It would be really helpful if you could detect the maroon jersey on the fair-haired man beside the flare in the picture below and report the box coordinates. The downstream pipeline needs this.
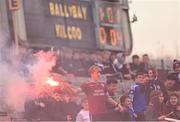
[81,82,107,115]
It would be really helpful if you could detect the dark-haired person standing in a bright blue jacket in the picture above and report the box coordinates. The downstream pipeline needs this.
[129,72,146,121]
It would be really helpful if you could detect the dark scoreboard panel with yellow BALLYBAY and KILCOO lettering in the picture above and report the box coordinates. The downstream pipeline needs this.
[23,0,96,48]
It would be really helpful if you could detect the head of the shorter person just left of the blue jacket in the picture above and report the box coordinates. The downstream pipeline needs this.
[120,95,132,108]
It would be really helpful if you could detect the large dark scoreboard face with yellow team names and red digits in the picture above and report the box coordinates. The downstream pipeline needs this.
[23,0,132,51]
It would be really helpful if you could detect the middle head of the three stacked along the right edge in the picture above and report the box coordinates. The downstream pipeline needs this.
[164,74,176,90]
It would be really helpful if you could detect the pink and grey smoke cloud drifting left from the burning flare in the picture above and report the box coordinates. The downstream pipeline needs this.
[0,32,56,112]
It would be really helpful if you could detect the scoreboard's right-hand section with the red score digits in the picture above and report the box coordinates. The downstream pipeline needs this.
[95,1,124,51]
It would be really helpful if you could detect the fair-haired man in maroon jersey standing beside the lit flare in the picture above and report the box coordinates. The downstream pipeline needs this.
[81,65,123,121]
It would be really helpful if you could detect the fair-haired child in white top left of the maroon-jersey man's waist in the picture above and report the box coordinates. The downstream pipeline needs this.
[76,98,90,122]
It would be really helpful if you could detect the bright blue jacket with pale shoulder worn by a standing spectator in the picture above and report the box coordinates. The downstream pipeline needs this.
[129,83,146,114]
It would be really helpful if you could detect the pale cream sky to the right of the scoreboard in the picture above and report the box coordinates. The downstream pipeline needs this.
[129,0,180,58]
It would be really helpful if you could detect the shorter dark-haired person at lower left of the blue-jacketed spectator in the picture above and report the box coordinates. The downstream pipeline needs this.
[120,95,137,121]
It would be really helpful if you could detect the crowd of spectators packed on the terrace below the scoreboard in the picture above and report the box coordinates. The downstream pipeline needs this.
[25,51,180,122]
